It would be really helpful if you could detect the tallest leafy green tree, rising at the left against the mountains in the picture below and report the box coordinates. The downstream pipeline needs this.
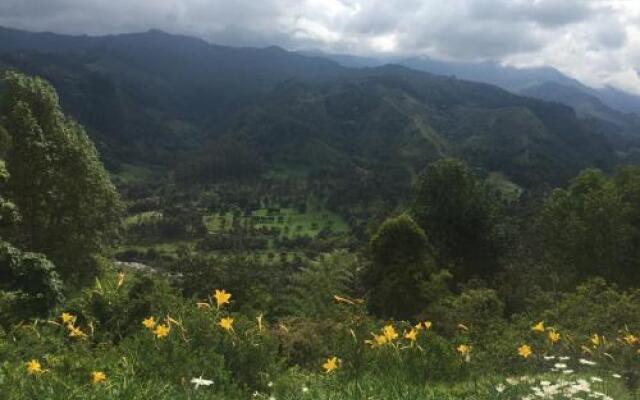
[0,72,121,276]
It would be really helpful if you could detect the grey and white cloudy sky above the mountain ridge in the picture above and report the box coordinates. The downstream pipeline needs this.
[0,0,640,93]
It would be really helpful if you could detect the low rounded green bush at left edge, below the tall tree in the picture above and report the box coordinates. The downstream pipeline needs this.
[0,242,64,324]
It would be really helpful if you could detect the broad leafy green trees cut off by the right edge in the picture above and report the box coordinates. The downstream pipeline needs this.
[539,168,640,284]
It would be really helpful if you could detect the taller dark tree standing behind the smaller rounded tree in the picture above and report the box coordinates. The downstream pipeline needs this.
[411,159,498,280]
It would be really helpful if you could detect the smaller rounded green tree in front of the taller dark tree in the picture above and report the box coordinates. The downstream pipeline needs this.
[364,214,435,318]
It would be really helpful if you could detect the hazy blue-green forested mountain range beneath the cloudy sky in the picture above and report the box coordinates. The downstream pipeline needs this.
[0,28,640,186]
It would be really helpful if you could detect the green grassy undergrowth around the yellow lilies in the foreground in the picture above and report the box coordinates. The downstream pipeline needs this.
[0,269,639,400]
